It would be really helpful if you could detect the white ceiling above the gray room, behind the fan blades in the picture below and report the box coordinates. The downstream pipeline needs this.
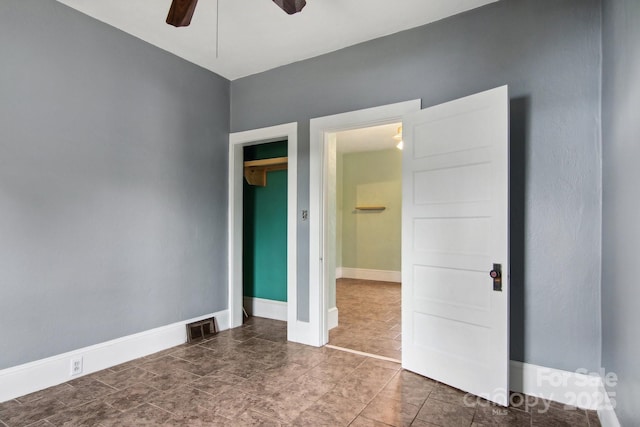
[58,0,497,80]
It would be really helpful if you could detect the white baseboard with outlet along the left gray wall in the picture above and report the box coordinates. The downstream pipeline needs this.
[0,310,229,402]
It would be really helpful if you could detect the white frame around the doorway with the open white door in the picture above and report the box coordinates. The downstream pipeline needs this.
[308,99,421,346]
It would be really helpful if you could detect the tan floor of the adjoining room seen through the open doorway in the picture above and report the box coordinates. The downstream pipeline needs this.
[329,279,402,361]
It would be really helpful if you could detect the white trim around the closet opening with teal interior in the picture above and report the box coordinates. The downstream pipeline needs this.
[228,122,299,341]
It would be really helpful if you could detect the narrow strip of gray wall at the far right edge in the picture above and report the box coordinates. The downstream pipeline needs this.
[602,0,640,426]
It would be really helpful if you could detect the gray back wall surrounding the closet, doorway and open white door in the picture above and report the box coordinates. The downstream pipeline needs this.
[231,0,601,370]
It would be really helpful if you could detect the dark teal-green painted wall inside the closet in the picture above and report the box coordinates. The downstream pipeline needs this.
[243,141,287,301]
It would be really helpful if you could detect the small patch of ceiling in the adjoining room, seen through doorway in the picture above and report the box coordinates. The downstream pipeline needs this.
[336,123,402,153]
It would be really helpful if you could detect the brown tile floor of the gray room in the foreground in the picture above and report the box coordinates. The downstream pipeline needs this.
[0,318,599,427]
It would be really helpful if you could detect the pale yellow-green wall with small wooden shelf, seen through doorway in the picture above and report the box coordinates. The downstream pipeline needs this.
[337,149,402,271]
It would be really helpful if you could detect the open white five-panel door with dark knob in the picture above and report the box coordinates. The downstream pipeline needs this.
[402,86,509,406]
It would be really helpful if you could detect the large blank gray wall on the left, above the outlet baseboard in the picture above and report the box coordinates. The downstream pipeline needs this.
[0,0,230,369]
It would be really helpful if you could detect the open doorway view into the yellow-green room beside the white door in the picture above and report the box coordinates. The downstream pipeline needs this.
[326,123,402,361]
